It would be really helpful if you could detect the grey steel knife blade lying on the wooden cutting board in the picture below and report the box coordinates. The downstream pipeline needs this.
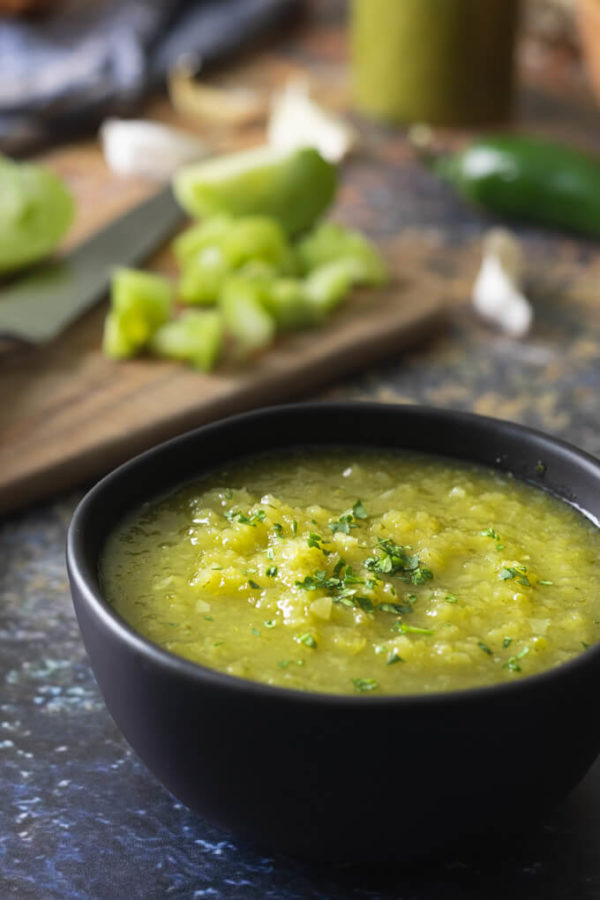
[0,186,185,344]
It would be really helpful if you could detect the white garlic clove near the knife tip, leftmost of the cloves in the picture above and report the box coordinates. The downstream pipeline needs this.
[100,119,207,181]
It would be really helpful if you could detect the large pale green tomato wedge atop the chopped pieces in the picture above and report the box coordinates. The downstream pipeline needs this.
[173,146,337,235]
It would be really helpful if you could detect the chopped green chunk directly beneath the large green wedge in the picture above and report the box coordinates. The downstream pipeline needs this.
[220,216,294,273]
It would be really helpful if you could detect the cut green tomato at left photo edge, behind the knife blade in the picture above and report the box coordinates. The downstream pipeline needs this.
[0,157,75,274]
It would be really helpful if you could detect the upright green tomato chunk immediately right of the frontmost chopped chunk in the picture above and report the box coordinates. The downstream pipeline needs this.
[219,277,275,354]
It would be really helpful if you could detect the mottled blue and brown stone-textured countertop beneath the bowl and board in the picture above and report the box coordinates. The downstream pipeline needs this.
[0,3,600,900]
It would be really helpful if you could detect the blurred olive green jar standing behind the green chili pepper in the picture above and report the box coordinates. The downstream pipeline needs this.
[351,0,519,125]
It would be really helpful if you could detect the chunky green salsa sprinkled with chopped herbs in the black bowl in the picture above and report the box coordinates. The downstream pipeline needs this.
[100,450,600,696]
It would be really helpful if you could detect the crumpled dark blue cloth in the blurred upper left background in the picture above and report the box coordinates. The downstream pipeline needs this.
[0,0,302,152]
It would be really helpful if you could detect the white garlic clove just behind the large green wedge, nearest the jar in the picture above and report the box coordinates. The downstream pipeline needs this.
[267,79,357,163]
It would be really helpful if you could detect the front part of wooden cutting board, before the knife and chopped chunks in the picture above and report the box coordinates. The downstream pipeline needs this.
[0,243,443,511]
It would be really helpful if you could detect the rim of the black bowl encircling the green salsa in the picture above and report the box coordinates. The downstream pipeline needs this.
[66,400,600,709]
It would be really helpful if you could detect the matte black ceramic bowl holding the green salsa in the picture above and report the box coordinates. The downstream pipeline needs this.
[68,403,600,861]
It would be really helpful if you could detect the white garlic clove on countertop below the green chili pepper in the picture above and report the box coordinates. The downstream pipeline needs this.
[473,229,533,337]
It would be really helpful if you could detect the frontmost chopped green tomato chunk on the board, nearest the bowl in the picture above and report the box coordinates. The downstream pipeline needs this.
[151,310,223,372]
